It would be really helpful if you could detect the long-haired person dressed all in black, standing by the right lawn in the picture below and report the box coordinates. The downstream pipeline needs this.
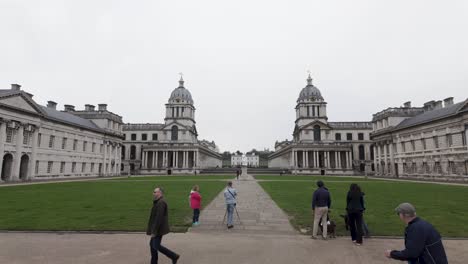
[346,183,366,246]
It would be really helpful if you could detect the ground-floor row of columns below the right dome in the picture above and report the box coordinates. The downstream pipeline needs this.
[291,149,352,169]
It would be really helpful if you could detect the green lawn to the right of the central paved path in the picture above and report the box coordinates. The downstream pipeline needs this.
[256,176,468,237]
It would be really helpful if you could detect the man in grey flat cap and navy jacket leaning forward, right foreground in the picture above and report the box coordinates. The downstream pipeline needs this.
[385,203,448,264]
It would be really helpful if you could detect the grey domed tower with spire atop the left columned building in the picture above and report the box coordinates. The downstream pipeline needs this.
[164,76,196,127]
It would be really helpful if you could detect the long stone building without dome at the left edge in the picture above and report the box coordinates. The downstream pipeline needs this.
[0,84,123,182]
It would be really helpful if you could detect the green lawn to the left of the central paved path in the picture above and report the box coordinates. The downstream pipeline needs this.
[0,176,232,231]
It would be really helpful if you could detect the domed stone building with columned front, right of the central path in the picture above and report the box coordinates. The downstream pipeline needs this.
[268,75,374,175]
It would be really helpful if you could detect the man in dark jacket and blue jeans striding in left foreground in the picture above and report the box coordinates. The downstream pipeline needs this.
[146,187,180,264]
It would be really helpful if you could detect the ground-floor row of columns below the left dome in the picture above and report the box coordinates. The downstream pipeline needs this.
[142,150,199,169]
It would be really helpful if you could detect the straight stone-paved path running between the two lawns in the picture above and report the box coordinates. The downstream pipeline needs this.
[190,171,296,235]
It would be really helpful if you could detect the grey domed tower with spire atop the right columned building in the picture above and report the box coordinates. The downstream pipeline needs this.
[296,74,328,127]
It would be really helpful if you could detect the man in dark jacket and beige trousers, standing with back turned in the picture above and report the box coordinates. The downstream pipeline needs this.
[312,181,331,239]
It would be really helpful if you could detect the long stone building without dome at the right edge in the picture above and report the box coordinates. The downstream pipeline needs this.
[371,97,468,181]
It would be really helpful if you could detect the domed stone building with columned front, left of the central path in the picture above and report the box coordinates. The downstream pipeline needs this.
[122,77,222,174]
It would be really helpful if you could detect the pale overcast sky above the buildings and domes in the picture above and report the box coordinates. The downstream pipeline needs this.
[0,0,468,151]
